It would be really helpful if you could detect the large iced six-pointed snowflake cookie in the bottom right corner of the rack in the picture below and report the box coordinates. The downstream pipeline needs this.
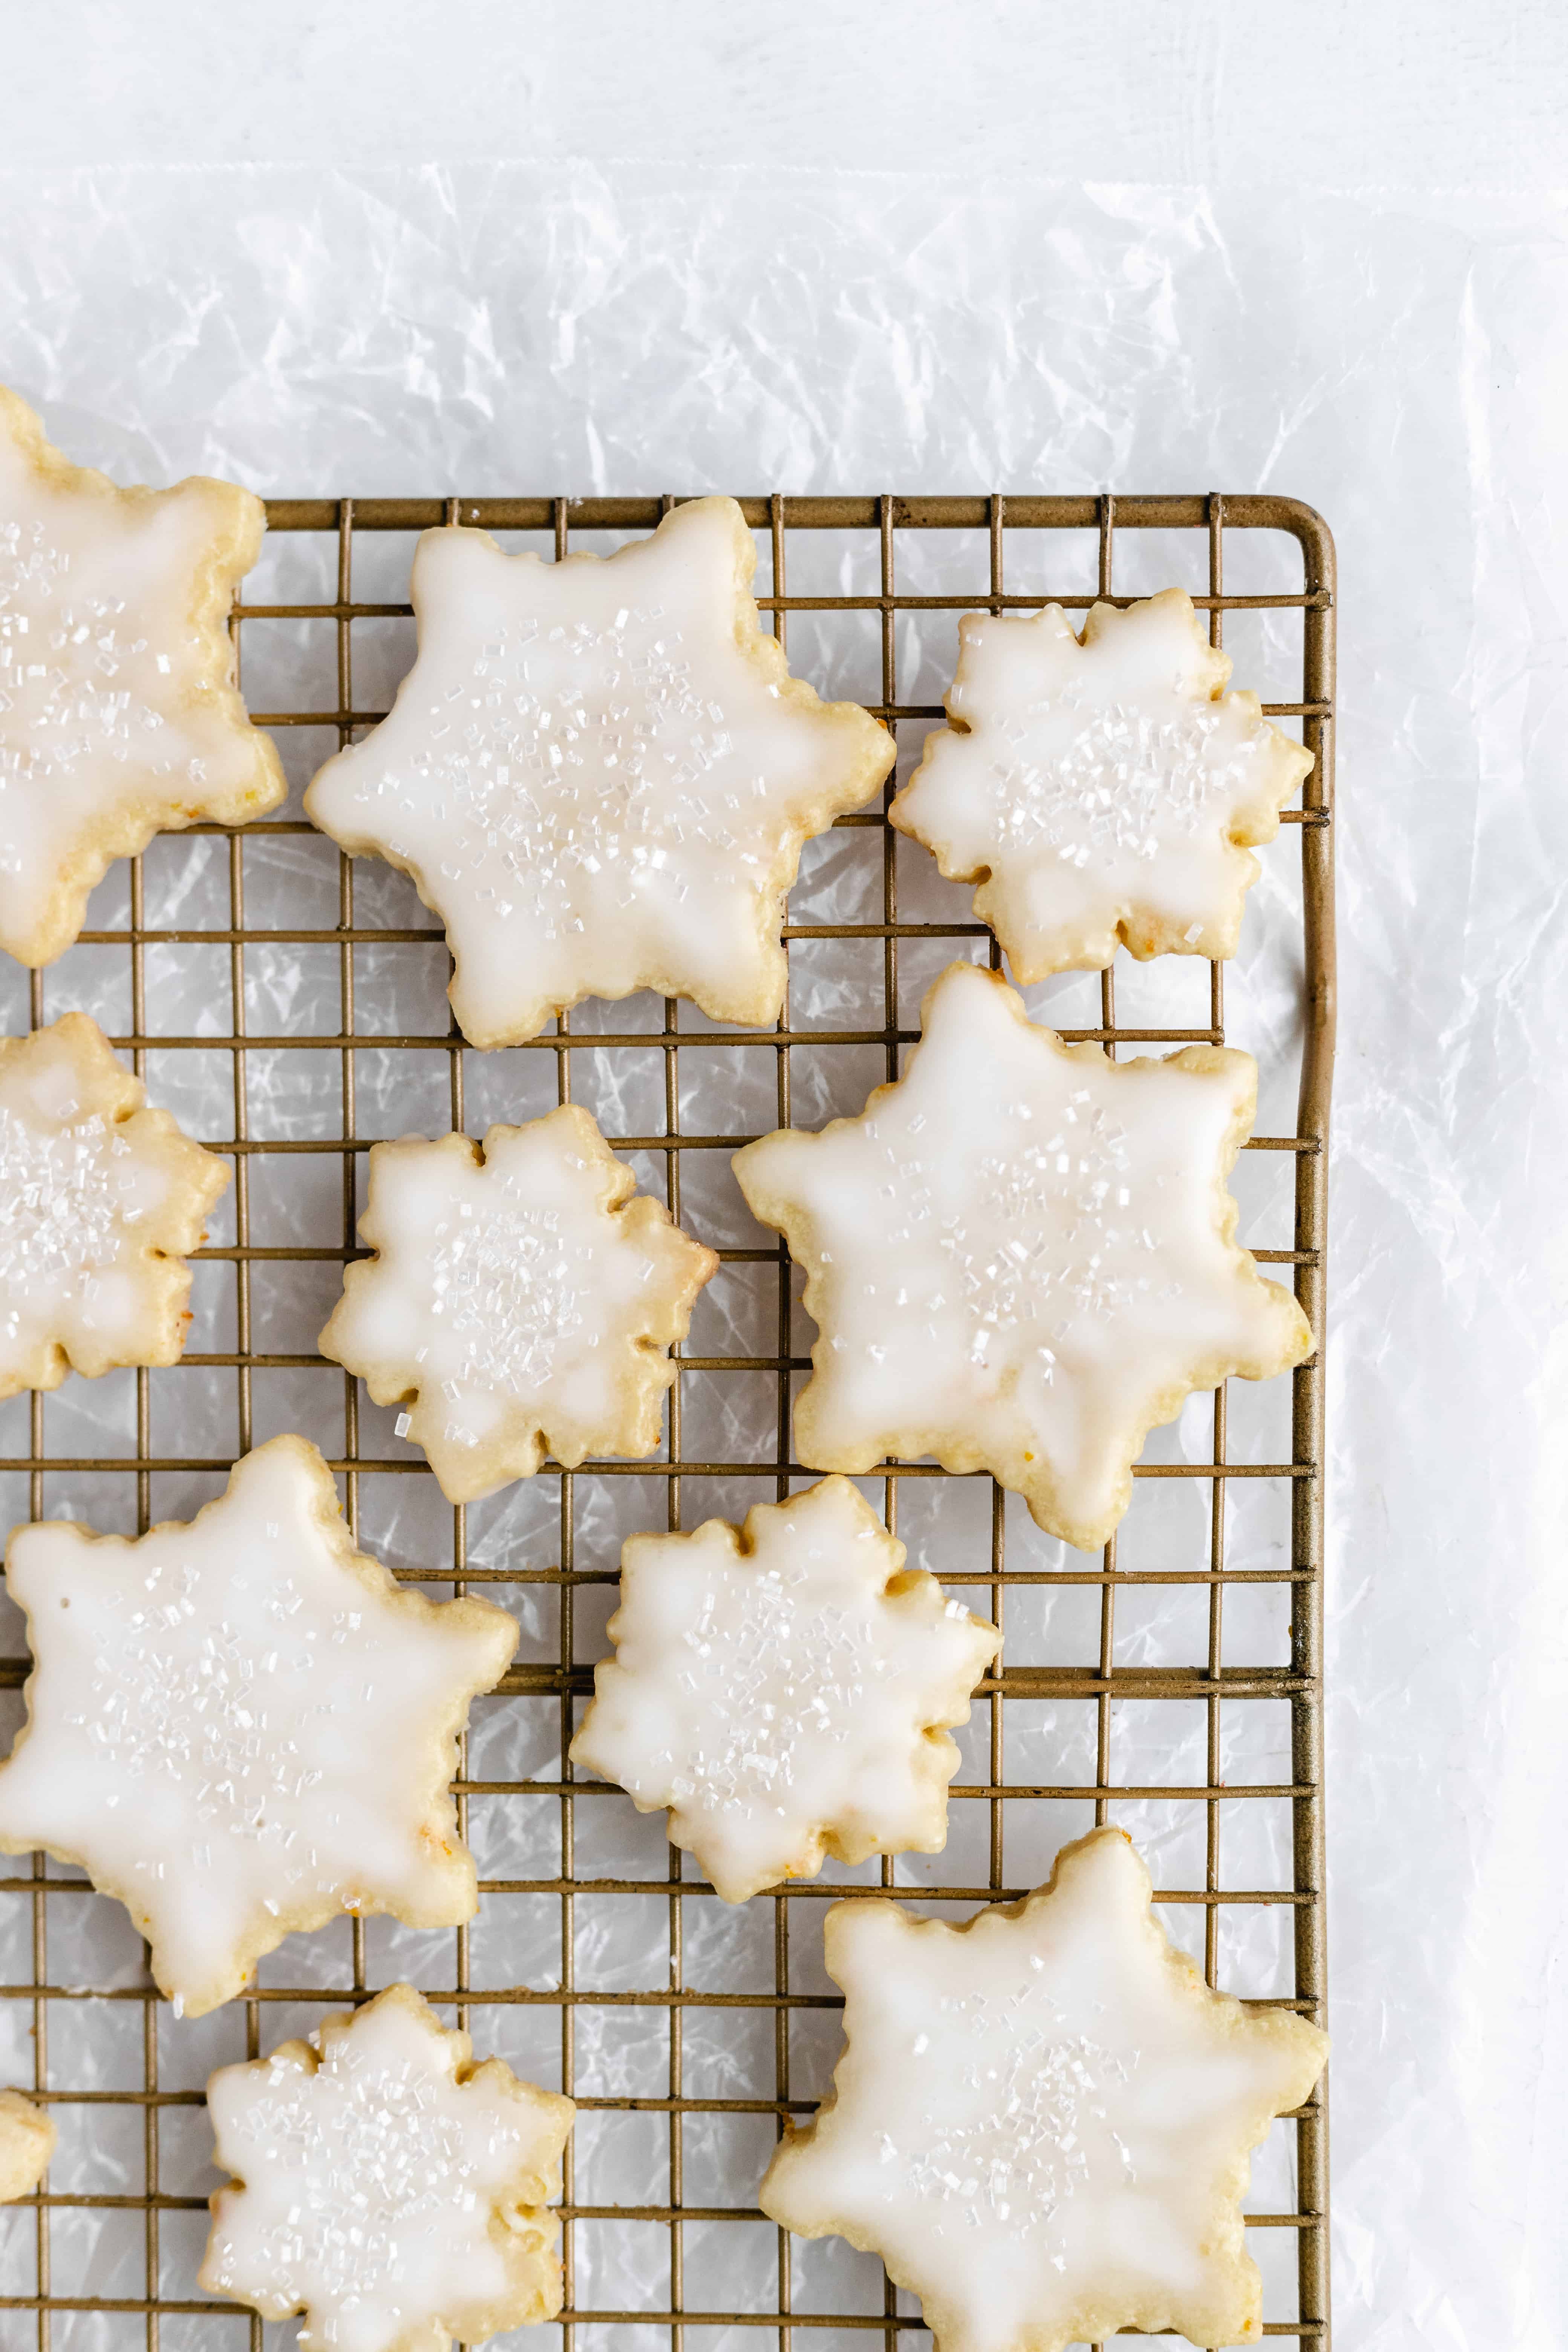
[760,1830,1328,2352]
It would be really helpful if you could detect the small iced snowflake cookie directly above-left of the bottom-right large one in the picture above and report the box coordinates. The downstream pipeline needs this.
[571,1477,1001,1903]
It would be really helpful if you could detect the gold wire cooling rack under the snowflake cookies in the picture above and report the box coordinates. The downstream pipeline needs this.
[0,494,1333,2352]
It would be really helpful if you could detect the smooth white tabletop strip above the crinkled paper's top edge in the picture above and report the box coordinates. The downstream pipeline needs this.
[0,0,1568,190]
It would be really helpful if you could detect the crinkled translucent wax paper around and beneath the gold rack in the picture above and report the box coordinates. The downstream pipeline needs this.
[0,167,1568,2352]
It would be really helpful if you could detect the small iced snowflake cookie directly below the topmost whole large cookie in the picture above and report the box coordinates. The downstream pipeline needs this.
[320,1103,719,1503]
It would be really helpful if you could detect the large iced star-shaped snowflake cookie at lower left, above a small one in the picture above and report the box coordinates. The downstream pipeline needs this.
[0,1437,517,2016]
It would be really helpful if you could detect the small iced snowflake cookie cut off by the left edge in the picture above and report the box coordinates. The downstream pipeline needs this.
[0,1014,228,1397]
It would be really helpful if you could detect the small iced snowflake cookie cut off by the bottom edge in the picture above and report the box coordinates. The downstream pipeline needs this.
[200,1985,576,2352]
